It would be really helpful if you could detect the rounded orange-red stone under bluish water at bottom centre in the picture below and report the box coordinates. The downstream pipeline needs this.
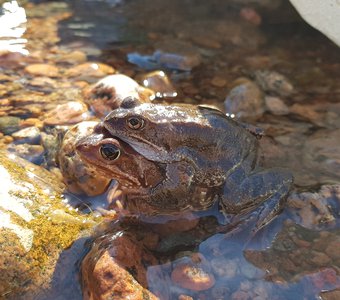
[171,255,215,291]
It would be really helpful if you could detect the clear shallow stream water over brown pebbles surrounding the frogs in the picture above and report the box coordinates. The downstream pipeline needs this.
[0,0,340,299]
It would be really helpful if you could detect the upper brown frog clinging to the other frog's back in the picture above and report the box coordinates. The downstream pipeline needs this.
[102,98,293,230]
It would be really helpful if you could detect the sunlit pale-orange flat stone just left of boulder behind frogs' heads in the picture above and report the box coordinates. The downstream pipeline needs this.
[43,101,90,125]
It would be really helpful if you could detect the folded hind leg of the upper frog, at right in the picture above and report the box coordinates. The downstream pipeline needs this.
[221,169,293,231]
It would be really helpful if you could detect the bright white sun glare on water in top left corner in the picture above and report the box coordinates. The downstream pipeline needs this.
[0,1,28,55]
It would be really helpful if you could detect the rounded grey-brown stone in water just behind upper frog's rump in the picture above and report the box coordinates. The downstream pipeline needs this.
[224,78,264,120]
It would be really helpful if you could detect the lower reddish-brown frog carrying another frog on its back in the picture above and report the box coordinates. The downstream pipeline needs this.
[75,123,215,219]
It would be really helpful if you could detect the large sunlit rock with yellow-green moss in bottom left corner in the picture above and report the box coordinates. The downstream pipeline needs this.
[0,151,100,299]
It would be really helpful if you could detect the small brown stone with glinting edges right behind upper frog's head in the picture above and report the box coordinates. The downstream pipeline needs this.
[140,71,177,98]
